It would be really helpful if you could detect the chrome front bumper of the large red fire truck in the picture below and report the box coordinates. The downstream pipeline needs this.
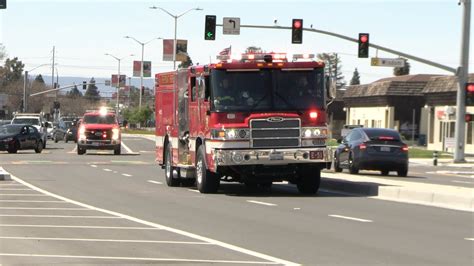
[212,147,332,166]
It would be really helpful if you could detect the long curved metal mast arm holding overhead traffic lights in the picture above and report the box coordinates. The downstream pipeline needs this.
[216,24,456,74]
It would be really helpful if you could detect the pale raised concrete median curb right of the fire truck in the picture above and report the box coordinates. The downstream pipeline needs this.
[321,173,474,212]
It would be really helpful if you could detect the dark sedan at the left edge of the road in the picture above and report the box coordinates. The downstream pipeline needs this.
[0,125,43,153]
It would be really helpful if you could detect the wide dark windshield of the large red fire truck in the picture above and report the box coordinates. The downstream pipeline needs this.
[211,68,324,112]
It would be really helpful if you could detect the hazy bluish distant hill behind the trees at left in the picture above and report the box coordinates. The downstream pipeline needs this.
[41,76,155,97]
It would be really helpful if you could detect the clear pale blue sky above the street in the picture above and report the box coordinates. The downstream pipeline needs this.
[0,0,474,83]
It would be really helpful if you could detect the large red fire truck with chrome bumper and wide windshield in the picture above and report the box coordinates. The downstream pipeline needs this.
[155,53,331,194]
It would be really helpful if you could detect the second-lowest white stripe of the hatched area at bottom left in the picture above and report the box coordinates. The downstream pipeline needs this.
[0,236,212,245]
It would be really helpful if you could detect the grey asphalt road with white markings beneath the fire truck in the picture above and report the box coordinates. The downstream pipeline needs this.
[0,138,474,265]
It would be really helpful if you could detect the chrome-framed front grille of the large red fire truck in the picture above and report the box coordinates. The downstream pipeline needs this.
[250,117,301,148]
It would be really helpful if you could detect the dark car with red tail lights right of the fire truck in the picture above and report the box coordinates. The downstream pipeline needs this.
[334,128,408,176]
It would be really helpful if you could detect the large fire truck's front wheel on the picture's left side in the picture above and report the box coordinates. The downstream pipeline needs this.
[196,145,220,193]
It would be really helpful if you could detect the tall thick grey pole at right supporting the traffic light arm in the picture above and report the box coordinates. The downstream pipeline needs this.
[454,0,471,163]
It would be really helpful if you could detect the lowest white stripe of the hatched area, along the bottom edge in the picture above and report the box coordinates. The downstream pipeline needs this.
[0,253,278,265]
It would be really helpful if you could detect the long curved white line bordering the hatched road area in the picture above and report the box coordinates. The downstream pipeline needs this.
[12,175,300,265]
